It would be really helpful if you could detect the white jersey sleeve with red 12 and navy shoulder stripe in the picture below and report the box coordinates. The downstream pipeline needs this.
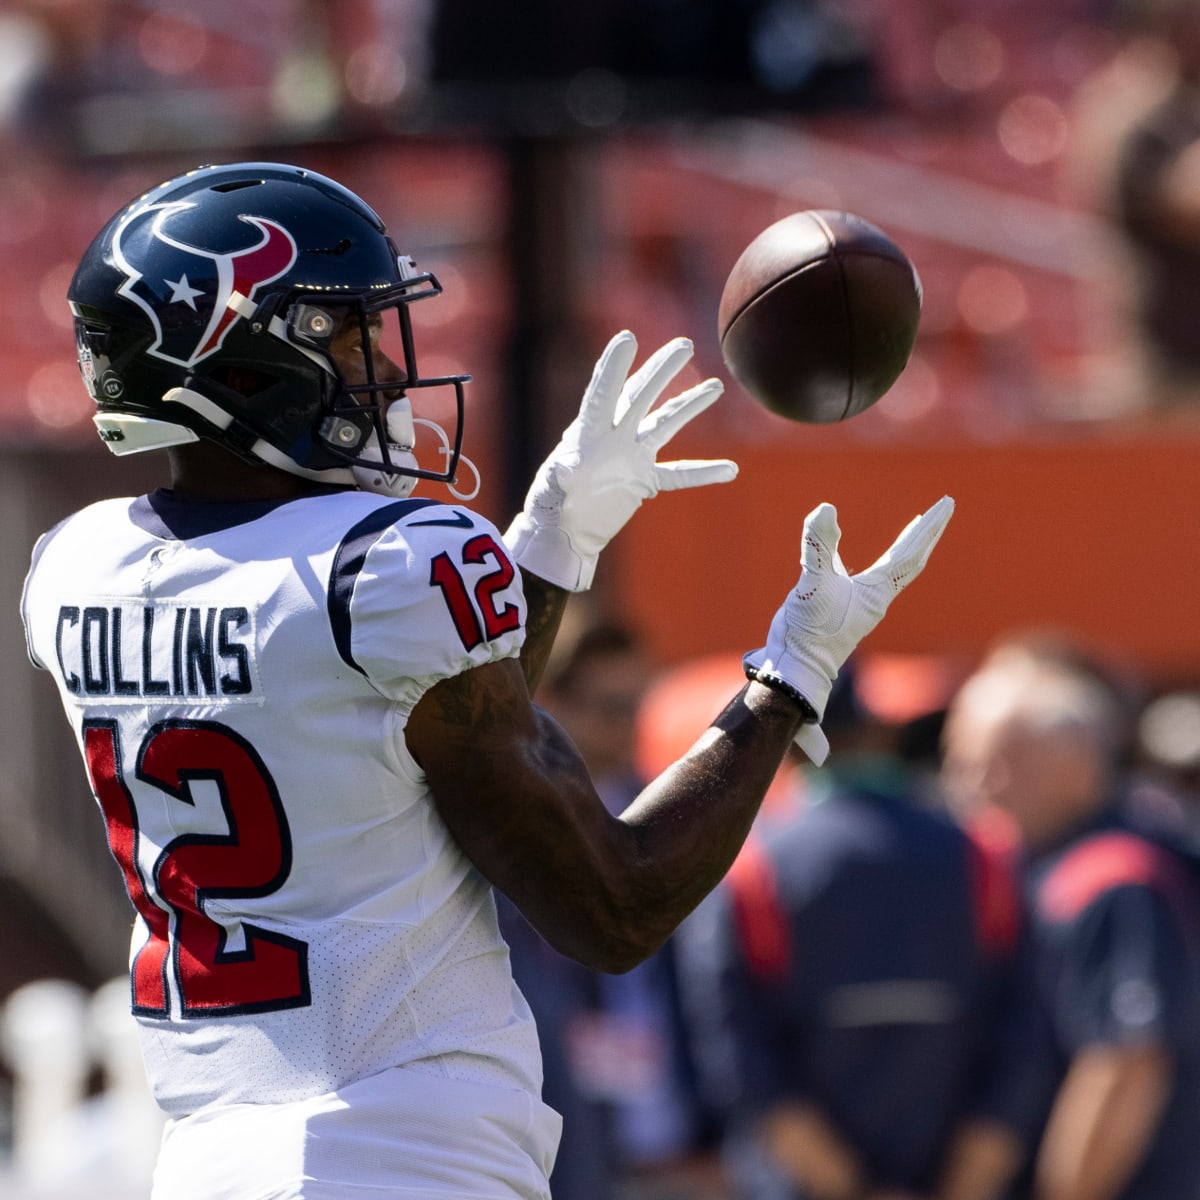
[329,505,526,707]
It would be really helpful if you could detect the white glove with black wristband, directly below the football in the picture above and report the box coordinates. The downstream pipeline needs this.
[742,496,954,767]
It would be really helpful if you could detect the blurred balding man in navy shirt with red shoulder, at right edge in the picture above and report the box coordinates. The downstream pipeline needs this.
[944,638,1200,1200]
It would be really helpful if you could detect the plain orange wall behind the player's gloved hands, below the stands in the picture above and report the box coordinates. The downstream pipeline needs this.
[601,421,1200,684]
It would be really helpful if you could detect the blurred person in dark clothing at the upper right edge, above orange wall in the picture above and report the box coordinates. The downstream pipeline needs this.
[1063,0,1200,413]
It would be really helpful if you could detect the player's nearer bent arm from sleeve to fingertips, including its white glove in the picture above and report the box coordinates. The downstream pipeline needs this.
[406,499,953,971]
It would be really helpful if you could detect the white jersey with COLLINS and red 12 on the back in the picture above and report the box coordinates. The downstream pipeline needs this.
[22,491,557,1195]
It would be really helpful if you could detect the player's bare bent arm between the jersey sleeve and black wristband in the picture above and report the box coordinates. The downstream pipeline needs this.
[407,660,802,972]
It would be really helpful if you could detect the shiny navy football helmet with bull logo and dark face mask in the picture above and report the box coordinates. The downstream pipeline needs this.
[67,162,469,490]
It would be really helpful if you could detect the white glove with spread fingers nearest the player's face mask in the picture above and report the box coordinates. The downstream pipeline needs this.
[504,330,738,592]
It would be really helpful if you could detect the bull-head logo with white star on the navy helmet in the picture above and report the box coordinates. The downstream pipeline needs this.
[113,200,298,367]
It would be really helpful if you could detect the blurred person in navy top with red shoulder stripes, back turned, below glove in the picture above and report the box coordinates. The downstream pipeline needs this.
[680,665,1019,1200]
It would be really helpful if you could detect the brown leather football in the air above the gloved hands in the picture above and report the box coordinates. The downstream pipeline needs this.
[718,209,922,425]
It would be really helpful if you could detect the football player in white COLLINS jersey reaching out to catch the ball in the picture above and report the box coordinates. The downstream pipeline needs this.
[22,163,953,1200]
